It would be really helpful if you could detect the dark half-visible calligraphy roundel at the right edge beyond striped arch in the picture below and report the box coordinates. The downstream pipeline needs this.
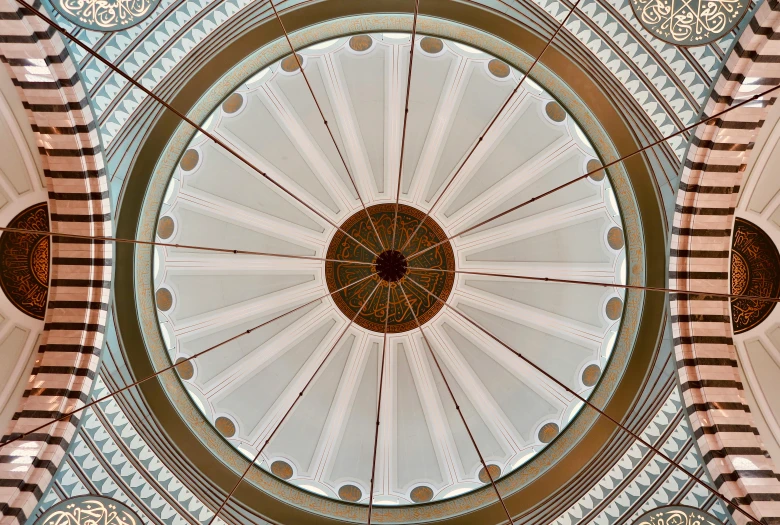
[731,217,780,334]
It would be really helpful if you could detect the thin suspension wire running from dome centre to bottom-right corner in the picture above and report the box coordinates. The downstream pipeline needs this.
[402,277,759,523]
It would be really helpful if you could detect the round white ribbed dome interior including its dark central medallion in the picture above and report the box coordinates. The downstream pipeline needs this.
[153,34,626,505]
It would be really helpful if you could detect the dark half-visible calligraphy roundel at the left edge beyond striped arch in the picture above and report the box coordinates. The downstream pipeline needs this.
[0,202,49,320]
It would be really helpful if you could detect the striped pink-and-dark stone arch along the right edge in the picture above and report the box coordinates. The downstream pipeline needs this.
[669,0,780,524]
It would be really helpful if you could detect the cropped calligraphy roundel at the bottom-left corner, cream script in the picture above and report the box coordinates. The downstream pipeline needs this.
[38,496,142,525]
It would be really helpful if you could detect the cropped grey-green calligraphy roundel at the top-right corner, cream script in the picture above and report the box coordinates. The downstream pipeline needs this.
[631,0,748,46]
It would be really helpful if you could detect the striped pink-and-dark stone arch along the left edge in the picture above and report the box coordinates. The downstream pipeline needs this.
[0,0,113,525]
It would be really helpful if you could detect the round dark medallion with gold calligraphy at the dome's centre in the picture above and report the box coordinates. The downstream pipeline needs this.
[325,204,455,333]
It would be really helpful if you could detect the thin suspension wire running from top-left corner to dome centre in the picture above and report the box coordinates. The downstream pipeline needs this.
[10,0,377,257]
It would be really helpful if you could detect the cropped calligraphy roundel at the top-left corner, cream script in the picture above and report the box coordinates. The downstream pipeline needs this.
[51,0,160,31]
